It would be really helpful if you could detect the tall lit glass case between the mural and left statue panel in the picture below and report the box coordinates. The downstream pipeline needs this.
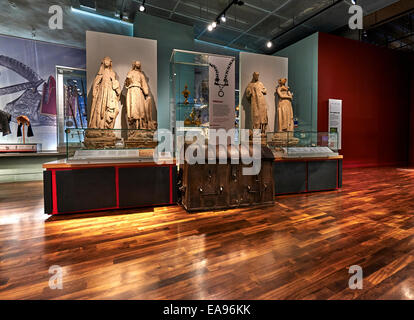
[56,66,88,151]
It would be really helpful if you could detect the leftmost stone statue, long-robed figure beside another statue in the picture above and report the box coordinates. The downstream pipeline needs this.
[88,57,121,129]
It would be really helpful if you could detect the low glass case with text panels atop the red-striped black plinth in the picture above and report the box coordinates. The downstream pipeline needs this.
[65,128,172,162]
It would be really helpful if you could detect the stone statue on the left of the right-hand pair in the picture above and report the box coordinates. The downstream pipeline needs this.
[246,72,268,134]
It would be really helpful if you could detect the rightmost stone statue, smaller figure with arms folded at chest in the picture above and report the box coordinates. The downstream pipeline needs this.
[276,78,295,132]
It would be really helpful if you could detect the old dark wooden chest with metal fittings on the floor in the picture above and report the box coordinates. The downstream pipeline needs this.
[180,147,274,211]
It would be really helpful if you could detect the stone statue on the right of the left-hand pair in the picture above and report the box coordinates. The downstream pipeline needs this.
[125,61,156,130]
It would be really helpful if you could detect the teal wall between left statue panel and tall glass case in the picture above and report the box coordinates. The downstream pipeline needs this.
[134,13,194,128]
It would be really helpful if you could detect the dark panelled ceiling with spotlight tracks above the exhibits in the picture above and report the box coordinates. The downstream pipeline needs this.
[71,0,398,53]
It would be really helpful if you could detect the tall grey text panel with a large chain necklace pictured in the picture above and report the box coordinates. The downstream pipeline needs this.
[208,55,236,130]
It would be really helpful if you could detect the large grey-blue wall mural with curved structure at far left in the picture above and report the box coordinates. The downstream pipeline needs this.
[0,36,86,150]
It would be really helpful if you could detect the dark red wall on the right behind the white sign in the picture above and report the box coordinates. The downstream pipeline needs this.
[318,33,411,166]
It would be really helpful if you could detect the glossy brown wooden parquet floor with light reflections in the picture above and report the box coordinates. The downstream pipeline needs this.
[0,168,414,299]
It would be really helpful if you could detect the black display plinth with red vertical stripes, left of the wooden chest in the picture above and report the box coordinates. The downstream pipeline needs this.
[43,161,177,214]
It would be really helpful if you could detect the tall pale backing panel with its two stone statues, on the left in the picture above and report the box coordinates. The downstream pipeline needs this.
[85,31,157,152]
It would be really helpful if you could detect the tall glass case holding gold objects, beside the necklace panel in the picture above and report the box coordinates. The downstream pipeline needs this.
[170,49,239,144]
